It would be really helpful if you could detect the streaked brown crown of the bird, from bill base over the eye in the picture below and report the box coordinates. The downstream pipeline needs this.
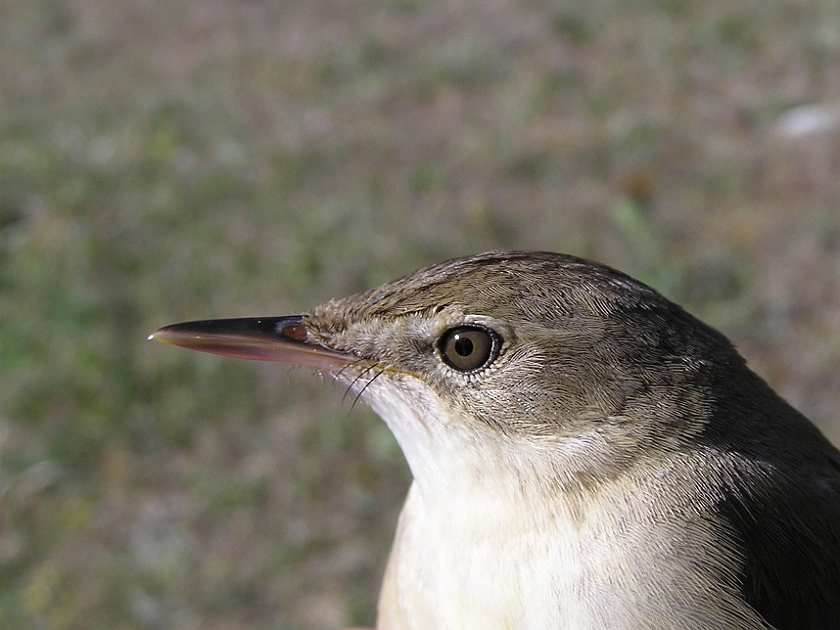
[304,252,669,360]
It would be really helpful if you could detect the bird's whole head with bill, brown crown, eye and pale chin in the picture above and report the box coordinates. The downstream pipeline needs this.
[151,252,743,494]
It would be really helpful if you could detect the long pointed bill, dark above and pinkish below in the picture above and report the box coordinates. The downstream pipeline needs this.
[149,315,354,372]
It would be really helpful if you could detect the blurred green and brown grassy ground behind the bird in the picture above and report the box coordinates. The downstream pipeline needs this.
[0,0,840,630]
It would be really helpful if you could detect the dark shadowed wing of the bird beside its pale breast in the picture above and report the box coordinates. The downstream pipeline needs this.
[719,434,840,630]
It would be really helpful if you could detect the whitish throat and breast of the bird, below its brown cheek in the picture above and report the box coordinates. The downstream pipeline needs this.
[354,379,766,630]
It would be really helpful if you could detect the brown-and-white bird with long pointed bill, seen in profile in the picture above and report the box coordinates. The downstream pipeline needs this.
[150,251,840,630]
